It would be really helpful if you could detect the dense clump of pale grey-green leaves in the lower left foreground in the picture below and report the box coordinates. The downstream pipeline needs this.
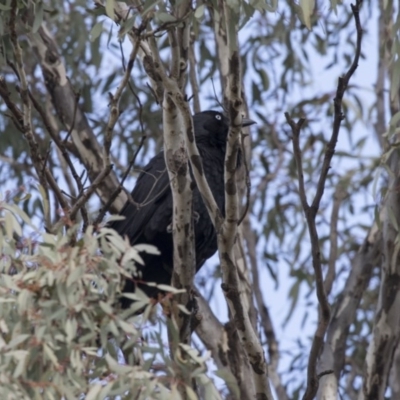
[0,202,220,400]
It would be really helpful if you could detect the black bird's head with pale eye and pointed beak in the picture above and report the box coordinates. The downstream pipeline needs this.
[193,110,256,146]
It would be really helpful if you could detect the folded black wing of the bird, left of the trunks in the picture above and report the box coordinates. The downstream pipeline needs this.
[109,152,171,244]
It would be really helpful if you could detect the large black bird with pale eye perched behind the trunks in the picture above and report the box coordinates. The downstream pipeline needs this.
[110,111,255,307]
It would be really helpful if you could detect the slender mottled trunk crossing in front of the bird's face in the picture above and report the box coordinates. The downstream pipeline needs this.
[217,1,272,399]
